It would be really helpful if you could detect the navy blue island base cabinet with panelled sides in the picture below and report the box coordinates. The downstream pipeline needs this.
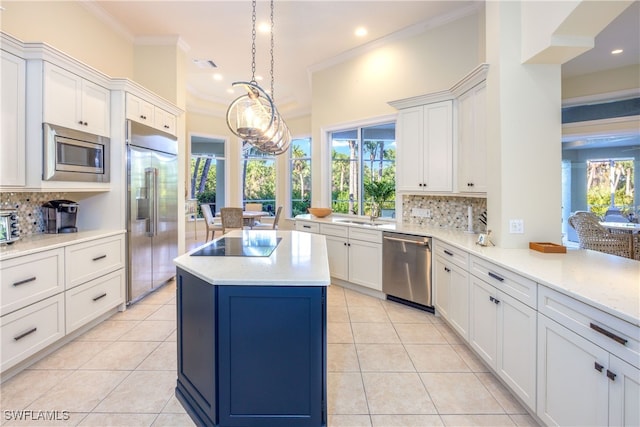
[176,269,327,427]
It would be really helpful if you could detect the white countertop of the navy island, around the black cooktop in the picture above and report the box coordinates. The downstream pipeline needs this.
[174,230,331,286]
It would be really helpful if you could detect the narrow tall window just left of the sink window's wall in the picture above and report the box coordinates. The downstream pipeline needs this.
[290,138,311,217]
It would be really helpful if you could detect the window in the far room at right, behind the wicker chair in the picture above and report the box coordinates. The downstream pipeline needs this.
[587,159,634,217]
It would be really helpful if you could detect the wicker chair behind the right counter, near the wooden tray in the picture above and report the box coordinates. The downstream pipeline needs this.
[569,212,632,258]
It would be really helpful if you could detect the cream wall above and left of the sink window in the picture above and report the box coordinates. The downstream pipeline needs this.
[311,13,484,206]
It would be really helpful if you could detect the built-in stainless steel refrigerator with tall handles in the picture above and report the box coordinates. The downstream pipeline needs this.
[125,120,178,303]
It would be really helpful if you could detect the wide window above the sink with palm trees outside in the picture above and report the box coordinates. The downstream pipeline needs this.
[329,123,396,218]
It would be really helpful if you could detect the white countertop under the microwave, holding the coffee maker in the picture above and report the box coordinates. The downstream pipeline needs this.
[0,230,126,261]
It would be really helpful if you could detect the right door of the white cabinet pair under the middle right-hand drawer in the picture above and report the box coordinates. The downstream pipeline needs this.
[496,291,536,411]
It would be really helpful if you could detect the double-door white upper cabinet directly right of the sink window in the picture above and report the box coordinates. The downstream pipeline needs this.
[396,101,453,193]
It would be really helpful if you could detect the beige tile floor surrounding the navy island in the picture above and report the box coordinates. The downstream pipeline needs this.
[0,283,536,427]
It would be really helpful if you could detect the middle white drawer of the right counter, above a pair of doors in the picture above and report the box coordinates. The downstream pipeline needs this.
[469,256,537,309]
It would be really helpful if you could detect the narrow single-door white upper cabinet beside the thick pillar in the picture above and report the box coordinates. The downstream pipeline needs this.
[458,82,487,193]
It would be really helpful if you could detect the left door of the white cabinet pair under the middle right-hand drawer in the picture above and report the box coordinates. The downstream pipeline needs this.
[469,276,498,369]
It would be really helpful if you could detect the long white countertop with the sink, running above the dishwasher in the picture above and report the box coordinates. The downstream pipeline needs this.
[296,215,640,326]
